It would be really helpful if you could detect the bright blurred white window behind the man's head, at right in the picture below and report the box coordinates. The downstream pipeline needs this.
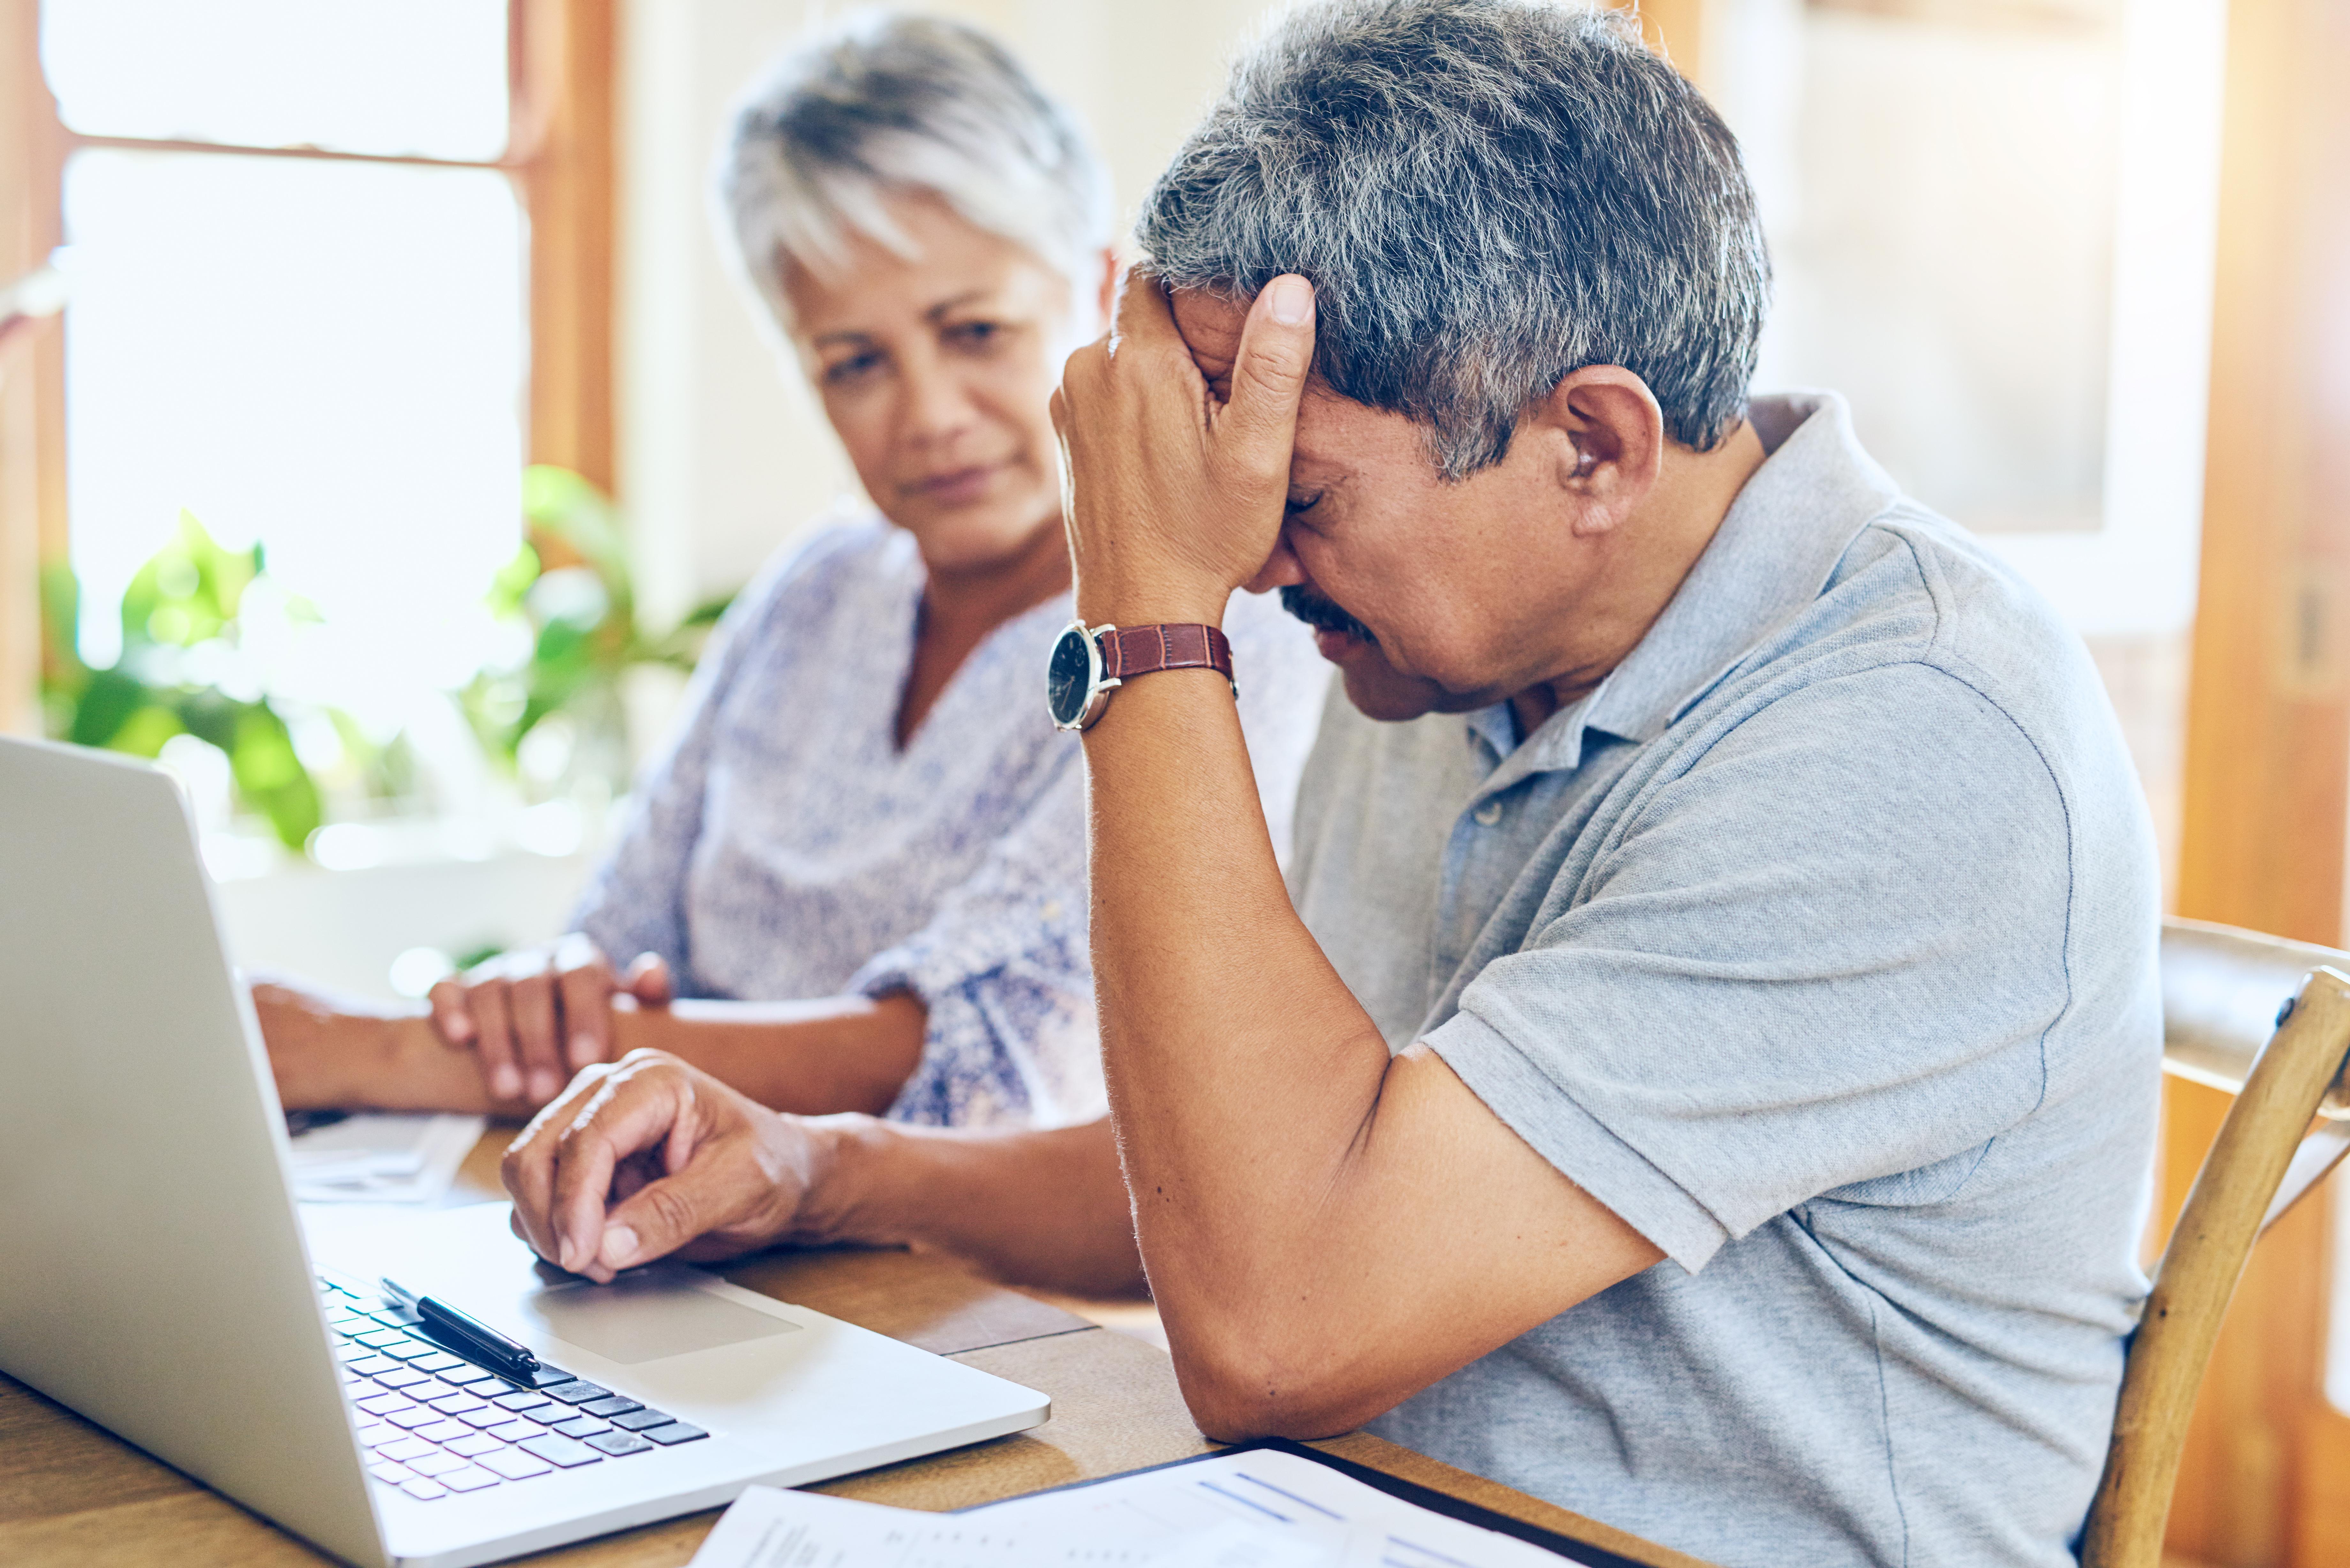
[1706,0,2225,639]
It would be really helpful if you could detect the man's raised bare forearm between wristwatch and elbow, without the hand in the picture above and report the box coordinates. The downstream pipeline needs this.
[1086,675,1389,1361]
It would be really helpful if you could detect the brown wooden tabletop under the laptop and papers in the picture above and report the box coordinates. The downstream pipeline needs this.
[0,1131,1704,1568]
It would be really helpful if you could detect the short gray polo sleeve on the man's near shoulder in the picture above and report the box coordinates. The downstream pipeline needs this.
[1427,663,2073,1272]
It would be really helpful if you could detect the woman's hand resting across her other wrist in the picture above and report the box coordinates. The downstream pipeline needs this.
[430,931,670,1105]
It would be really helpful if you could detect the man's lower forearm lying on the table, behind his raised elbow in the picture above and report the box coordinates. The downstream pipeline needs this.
[797,1117,1142,1298]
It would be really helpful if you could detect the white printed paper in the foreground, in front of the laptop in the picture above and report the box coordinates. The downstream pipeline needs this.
[693,1448,1565,1568]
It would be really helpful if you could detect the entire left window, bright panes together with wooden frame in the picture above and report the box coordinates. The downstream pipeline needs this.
[0,0,611,860]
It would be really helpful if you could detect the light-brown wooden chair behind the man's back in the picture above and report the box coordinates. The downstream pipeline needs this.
[2080,919,2350,1568]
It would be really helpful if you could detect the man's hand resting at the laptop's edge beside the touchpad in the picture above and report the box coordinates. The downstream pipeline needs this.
[501,1051,827,1284]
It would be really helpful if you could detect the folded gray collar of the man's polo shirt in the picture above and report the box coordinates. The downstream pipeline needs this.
[1469,393,1901,795]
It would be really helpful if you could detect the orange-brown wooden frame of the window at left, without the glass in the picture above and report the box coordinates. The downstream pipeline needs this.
[0,0,618,734]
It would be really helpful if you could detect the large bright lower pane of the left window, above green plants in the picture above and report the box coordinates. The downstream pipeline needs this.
[64,148,527,691]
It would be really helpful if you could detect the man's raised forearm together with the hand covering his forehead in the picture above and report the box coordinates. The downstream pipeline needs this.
[1053,273,1429,1432]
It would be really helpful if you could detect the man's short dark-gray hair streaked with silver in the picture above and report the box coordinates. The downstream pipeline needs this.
[1135,0,1770,479]
